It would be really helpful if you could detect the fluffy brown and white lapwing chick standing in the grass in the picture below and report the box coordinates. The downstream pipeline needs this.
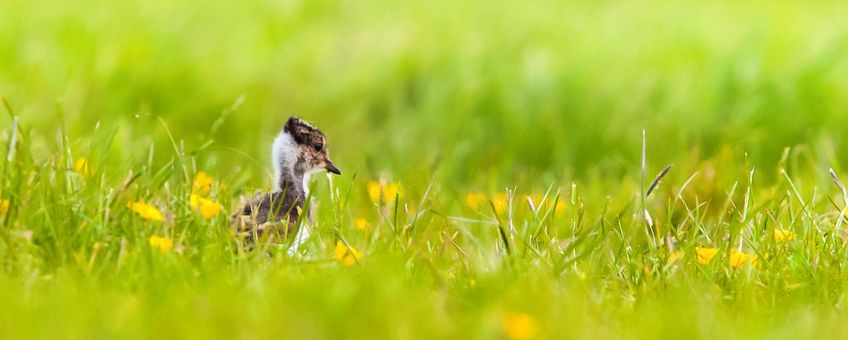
[233,117,341,244]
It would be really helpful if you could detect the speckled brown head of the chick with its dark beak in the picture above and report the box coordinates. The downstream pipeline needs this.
[281,117,341,175]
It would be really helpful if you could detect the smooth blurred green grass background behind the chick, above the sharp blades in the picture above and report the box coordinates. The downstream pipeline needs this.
[6,1,848,184]
